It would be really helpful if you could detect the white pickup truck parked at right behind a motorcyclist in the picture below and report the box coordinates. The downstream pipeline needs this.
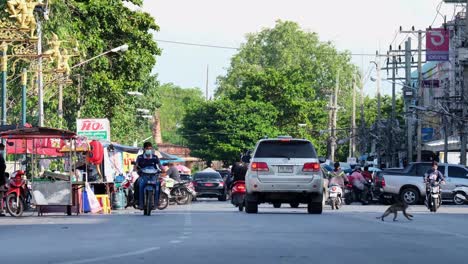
[377,162,468,205]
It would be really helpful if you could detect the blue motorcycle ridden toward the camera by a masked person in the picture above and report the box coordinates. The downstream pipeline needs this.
[138,167,161,216]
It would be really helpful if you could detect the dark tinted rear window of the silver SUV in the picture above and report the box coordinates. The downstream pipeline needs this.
[255,140,317,158]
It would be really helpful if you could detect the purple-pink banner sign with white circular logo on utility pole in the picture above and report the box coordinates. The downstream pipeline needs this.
[426,28,450,61]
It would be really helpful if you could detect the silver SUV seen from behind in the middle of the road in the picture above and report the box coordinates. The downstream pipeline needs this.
[245,137,324,214]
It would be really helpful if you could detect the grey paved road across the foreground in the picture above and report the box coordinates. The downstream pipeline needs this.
[0,200,468,264]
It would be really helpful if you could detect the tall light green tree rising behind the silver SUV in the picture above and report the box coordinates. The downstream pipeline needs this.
[216,21,356,155]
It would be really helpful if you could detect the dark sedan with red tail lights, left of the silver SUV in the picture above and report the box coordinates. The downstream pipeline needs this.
[193,172,227,201]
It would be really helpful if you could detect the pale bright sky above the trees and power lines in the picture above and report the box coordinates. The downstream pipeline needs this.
[143,0,460,96]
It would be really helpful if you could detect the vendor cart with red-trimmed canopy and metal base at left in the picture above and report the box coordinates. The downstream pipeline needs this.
[0,127,79,216]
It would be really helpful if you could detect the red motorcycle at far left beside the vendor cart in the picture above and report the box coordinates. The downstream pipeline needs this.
[4,170,31,217]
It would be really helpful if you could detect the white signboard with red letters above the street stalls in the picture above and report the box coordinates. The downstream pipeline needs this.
[76,118,110,141]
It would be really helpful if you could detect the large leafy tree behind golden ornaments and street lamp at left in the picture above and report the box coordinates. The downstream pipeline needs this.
[3,0,160,143]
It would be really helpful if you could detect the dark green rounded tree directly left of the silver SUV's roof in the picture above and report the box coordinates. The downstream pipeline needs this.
[181,99,279,162]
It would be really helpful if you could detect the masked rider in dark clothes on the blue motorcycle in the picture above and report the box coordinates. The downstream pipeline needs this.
[133,142,161,209]
